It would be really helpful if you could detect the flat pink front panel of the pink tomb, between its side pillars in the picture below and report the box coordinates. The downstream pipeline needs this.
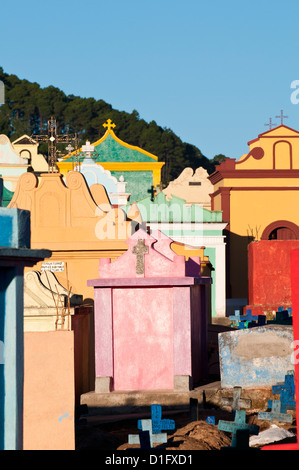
[113,288,174,390]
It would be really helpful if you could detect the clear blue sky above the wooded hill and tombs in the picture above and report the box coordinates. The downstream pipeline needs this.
[0,0,299,159]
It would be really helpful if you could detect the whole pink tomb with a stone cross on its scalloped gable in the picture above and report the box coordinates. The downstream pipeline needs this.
[88,229,211,393]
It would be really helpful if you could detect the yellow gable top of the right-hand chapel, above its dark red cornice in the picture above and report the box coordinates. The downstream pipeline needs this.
[235,124,299,170]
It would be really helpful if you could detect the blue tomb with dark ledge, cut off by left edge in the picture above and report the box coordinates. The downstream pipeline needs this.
[0,208,51,450]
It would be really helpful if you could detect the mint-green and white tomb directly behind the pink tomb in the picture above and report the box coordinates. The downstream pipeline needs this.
[124,191,226,318]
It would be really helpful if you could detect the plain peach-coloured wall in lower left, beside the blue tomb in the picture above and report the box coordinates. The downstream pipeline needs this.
[23,331,75,450]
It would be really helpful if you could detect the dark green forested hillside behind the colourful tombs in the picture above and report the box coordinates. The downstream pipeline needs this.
[0,67,223,184]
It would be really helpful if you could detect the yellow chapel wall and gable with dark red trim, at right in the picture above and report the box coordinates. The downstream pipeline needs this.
[210,125,299,299]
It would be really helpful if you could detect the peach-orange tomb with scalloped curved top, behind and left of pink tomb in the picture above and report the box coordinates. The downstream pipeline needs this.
[9,171,136,299]
